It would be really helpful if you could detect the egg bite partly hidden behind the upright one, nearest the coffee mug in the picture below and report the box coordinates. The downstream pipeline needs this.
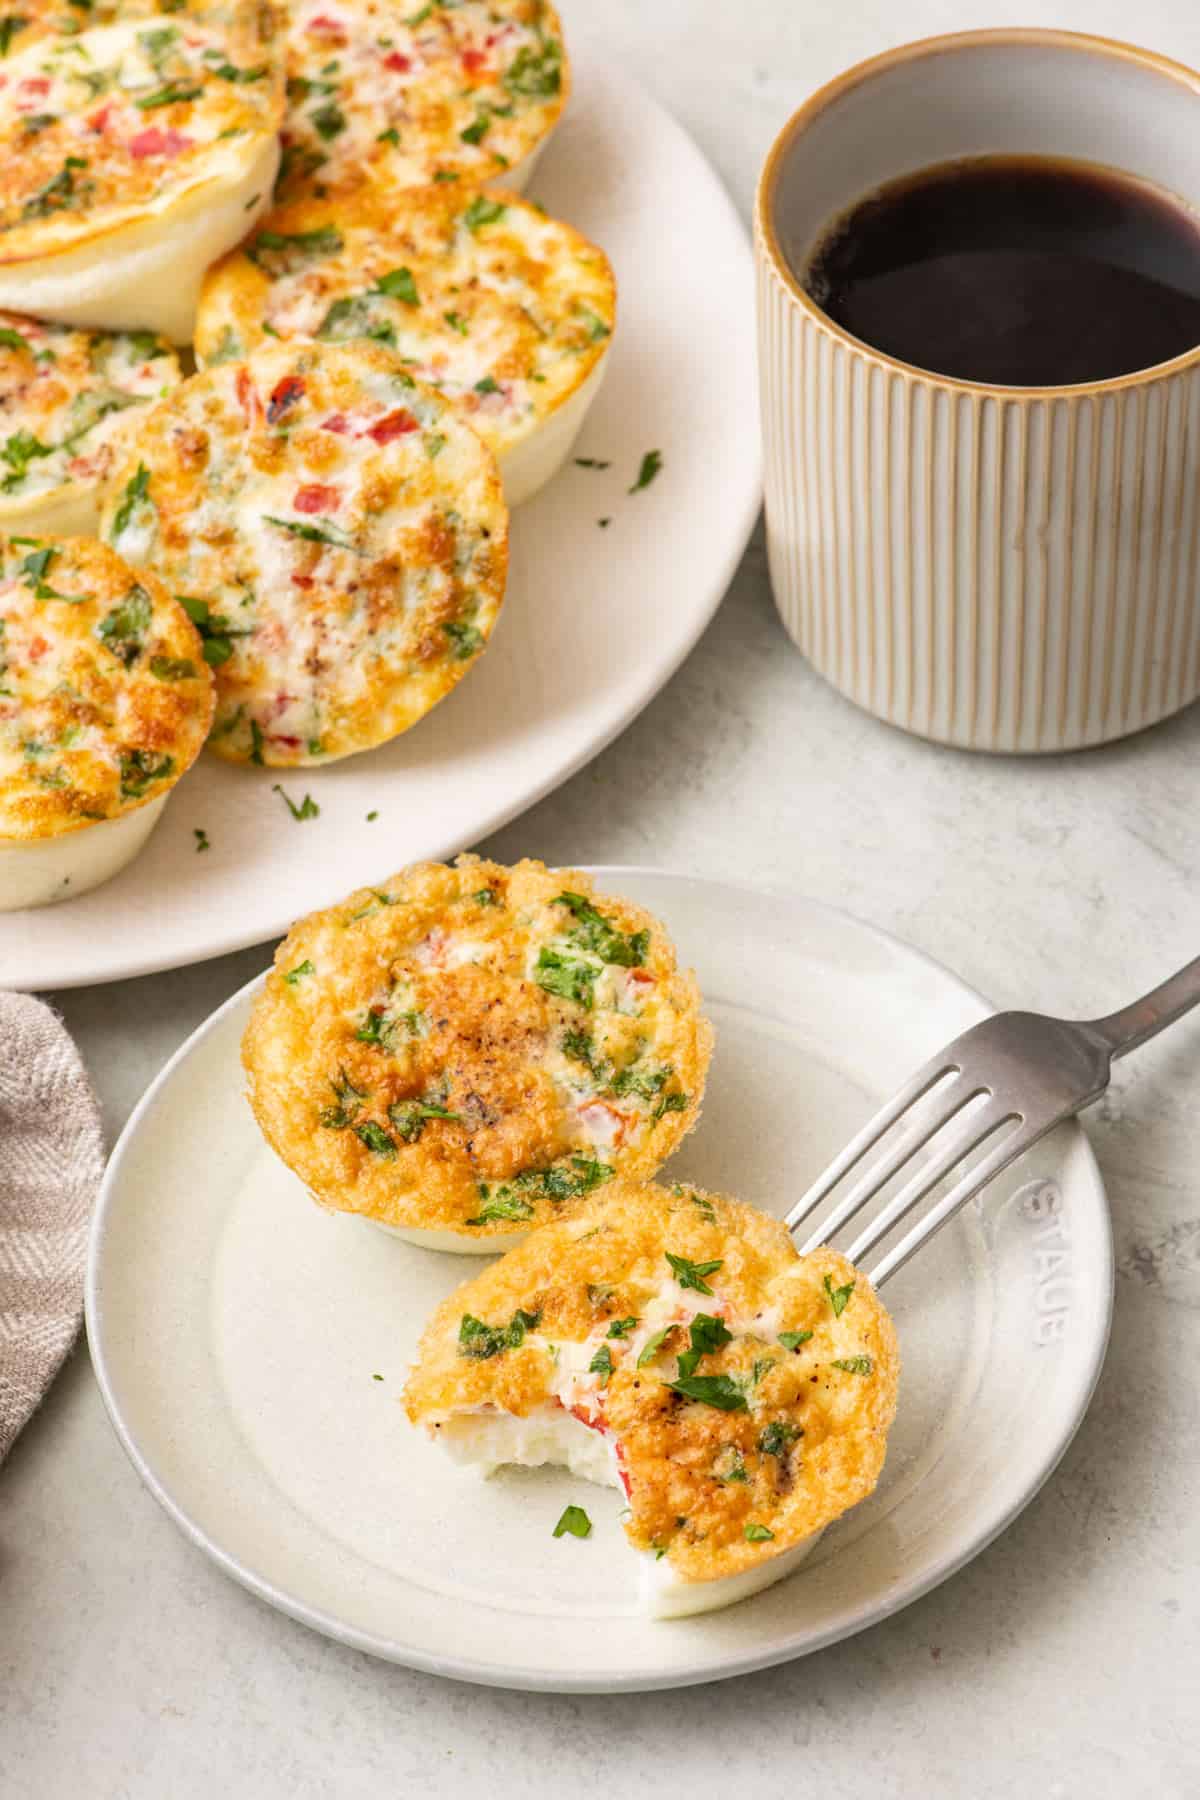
[196,182,617,506]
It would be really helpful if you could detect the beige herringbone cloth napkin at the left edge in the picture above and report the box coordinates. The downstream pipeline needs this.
[0,994,104,1462]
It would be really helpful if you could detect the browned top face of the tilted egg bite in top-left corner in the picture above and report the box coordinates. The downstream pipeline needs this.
[0,14,282,263]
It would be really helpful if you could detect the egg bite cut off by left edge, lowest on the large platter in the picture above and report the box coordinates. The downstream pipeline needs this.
[0,535,214,913]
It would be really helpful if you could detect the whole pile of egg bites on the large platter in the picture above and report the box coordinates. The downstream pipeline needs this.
[0,0,615,911]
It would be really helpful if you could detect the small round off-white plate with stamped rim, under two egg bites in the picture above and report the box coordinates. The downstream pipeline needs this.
[86,869,1112,1692]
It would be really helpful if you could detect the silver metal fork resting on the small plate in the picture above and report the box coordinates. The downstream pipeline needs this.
[786,956,1200,1287]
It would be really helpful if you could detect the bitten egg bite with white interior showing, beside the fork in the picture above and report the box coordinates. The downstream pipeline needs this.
[403,1181,900,1618]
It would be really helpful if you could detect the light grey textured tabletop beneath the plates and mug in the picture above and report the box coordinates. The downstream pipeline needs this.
[0,0,1200,1800]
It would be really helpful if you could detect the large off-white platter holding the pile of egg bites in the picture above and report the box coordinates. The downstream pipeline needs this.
[0,40,761,988]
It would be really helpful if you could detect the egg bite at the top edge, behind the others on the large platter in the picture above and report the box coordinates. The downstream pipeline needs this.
[279,0,570,198]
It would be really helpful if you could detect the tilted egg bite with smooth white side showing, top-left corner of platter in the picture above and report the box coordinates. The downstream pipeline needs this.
[0,7,282,344]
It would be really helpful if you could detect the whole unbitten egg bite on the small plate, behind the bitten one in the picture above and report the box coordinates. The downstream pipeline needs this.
[243,857,712,1253]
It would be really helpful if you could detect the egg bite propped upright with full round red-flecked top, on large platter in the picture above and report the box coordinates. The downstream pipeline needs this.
[101,342,507,769]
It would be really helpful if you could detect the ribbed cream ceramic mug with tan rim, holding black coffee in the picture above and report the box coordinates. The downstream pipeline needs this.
[756,31,1200,751]
